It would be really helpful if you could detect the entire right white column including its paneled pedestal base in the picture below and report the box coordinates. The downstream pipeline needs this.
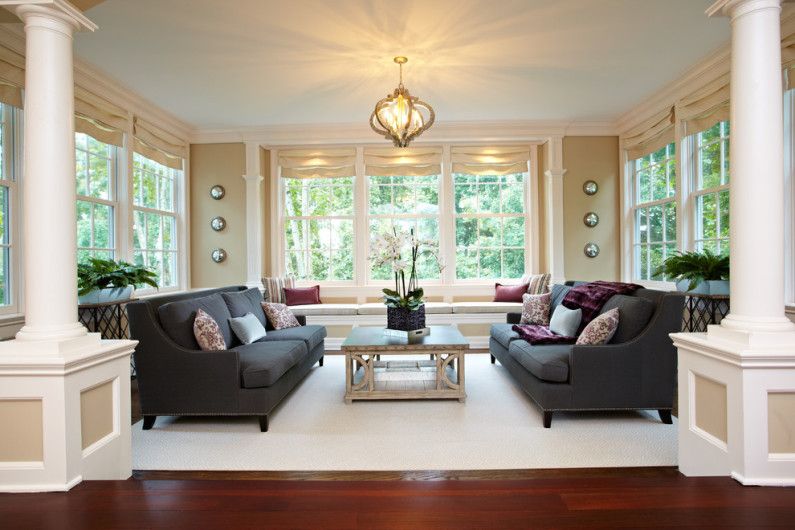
[672,0,795,486]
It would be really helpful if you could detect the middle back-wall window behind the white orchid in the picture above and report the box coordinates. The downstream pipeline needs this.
[367,175,441,280]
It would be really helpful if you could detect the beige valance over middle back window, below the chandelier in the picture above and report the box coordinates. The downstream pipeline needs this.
[364,147,442,177]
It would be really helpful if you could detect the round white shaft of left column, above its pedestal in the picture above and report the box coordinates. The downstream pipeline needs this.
[11,4,95,341]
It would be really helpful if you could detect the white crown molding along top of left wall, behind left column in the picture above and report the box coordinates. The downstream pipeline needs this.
[0,24,194,142]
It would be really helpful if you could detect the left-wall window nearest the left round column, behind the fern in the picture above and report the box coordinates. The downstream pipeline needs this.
[75,133,118,262]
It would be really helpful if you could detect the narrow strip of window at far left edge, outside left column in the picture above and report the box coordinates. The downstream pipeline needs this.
[0,103,21,310]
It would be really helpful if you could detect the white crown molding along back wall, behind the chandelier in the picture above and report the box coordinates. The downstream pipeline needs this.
[191,121,617,147]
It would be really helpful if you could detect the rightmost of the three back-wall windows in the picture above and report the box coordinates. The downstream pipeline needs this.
[453,173,526,279]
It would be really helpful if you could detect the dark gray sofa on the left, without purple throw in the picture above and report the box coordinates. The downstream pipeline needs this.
[127,286,326,432]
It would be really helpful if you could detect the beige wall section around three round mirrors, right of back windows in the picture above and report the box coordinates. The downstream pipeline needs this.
[563,136,621,280]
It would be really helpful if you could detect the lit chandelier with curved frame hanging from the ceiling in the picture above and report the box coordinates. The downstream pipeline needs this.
[370,57,436,147]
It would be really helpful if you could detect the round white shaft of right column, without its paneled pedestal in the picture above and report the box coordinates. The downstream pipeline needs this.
[708,0,795,344]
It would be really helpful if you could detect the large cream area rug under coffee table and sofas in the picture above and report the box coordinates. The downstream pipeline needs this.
[132,354,677,471]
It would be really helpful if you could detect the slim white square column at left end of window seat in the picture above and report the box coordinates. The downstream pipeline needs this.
[243,142,264,287]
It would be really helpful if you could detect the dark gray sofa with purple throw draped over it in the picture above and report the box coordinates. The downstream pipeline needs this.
[489,285,684,428]
